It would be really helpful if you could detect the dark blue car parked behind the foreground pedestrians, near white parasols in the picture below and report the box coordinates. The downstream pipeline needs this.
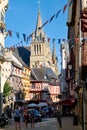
[23,109,42,123]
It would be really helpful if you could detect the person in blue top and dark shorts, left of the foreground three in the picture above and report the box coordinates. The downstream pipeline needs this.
[14,106,21,130]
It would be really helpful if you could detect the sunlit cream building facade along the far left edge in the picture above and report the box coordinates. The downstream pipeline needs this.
[0,0,8,115]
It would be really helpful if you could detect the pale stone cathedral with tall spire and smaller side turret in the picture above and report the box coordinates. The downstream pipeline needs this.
[30,9,59,76]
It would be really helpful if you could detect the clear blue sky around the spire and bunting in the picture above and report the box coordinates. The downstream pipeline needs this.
[5,0,68,70]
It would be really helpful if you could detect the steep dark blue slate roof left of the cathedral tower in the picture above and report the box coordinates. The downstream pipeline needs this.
[13,47,30,67]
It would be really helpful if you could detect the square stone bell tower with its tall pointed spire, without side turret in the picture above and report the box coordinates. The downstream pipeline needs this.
[30,10,52,68]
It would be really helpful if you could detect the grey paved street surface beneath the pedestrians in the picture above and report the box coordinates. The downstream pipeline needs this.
[0,117,81,130]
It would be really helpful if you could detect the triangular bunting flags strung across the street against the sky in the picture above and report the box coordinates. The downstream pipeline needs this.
[7,0,77,47]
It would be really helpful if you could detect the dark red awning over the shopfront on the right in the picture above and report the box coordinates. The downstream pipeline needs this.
[57,98,75,106]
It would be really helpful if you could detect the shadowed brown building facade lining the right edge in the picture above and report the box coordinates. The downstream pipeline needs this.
[67,0,87,129]
